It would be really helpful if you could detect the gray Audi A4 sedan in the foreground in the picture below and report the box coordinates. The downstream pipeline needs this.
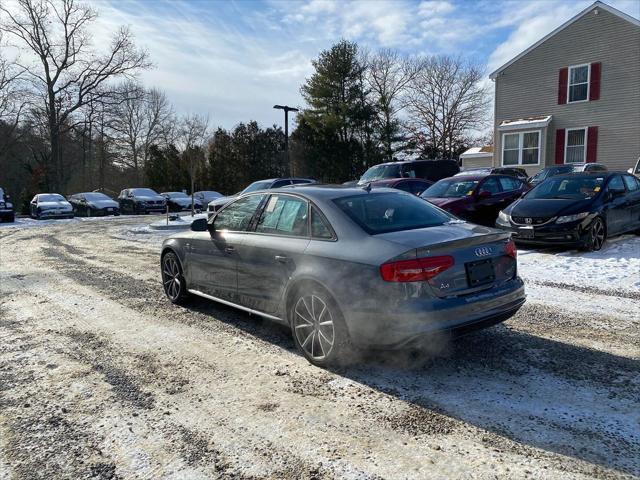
[161,185,525,367]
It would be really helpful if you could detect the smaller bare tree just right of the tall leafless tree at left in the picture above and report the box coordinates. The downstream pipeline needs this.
[111,81,174,183]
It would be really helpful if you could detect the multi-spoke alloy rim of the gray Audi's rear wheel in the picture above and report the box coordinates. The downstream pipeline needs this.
[293,294,336,361]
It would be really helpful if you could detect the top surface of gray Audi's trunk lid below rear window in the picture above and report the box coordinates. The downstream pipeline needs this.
[376,220,508,248]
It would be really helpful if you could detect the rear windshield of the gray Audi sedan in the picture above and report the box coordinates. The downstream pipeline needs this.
[333,192,454,235]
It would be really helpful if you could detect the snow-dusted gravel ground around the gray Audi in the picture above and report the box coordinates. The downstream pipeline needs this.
[0,217,640,480]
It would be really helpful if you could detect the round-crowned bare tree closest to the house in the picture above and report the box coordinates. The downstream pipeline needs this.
[407,56,490,158]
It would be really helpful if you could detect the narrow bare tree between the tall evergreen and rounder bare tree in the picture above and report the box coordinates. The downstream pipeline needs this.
[366,49,424,161]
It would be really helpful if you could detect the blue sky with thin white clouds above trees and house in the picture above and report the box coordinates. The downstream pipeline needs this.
[93,0,640,128]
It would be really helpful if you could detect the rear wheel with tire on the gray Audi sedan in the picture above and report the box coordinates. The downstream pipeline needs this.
[288,283,356,368]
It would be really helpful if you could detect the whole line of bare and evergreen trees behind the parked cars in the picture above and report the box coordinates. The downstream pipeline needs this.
[0,0,490,214]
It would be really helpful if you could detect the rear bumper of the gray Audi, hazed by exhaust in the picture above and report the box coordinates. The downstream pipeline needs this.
[343,277,525,349]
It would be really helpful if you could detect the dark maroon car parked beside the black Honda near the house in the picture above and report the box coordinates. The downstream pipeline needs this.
[421,174,530,226]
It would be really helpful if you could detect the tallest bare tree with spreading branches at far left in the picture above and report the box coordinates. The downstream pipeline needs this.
[0,0,150,188]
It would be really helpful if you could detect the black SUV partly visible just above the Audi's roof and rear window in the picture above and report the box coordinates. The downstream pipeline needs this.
[358,160,460,185]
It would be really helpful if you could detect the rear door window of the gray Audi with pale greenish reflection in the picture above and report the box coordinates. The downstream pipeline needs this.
[256,195,308,237]
